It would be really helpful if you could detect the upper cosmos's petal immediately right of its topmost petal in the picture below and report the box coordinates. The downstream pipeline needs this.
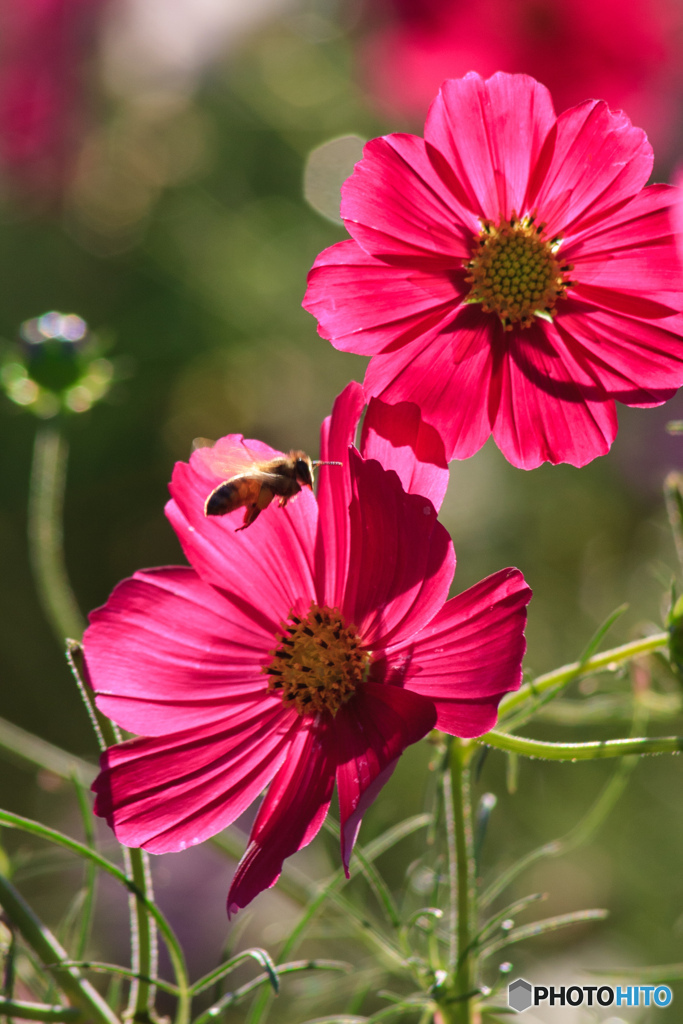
[528,99,652,236]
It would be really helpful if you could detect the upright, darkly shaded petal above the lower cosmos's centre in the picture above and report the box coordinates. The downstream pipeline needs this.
[342,450,456,649]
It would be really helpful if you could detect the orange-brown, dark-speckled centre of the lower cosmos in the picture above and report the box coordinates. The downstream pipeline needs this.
[263,604,371,715]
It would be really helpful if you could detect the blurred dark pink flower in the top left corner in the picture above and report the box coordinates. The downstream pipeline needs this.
[0,0,106,196]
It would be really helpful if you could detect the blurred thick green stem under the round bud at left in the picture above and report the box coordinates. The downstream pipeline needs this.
[29,426,85,644]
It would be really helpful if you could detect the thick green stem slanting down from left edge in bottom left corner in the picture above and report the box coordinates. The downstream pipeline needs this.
[0,874,119,1024]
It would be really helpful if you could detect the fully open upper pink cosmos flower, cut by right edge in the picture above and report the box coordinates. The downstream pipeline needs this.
[304,73,683,469]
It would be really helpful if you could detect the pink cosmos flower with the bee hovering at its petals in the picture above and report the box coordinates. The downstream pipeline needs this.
[84,384,530,912]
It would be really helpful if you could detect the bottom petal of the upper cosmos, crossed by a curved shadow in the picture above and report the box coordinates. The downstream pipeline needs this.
[494,323,617,469]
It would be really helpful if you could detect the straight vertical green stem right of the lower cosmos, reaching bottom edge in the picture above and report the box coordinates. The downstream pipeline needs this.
[439,736,476,1024]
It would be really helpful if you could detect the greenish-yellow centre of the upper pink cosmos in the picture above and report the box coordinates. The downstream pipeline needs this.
[465,213,573,331]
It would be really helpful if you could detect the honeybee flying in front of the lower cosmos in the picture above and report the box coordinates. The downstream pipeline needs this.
[196,444,342,530]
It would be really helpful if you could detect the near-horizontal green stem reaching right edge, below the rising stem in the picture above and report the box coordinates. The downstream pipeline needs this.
[477,729,683,761]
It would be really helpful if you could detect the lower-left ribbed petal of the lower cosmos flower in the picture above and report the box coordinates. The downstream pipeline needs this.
[93,700,300,853]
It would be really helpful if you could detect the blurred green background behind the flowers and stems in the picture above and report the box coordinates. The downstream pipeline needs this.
[0,2,683,1024]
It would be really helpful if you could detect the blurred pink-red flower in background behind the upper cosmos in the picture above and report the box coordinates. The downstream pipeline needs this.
[360,0,683,156]
